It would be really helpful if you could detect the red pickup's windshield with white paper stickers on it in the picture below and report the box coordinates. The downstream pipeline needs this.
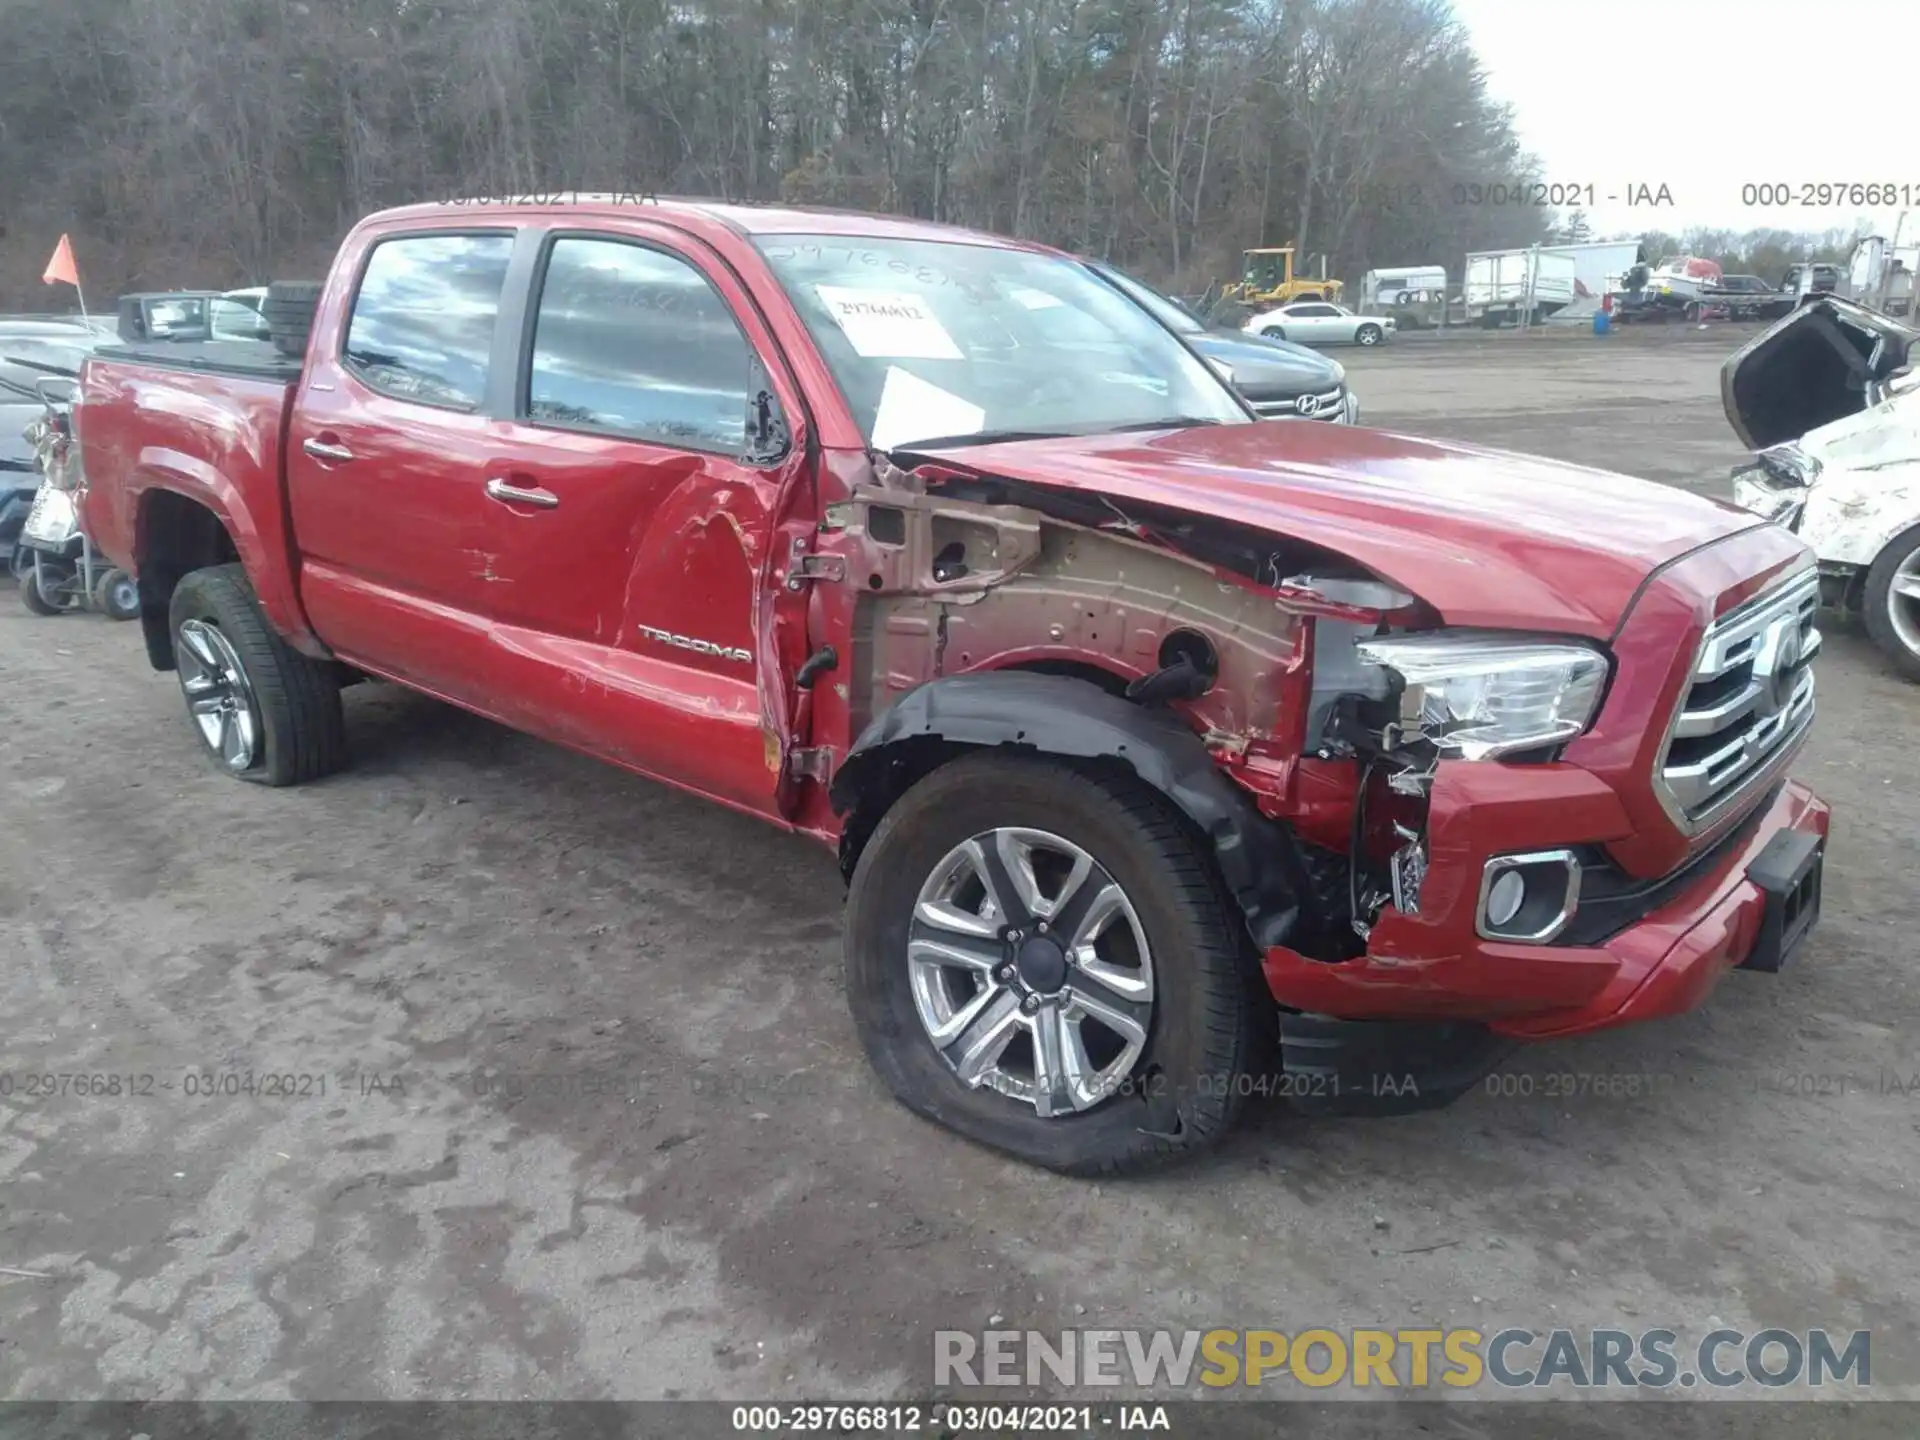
[758,234,1248,449]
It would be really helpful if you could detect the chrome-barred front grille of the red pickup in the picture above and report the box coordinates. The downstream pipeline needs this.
[1655,570,1820,833]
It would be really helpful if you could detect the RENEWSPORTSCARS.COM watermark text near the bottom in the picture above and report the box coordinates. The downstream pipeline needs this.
[933,1327,1872,1392]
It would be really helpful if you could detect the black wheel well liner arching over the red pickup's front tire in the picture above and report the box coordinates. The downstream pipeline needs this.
[829,670,1313,948]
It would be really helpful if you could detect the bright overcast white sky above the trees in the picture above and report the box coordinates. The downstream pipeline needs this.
[1453,0,1920,244]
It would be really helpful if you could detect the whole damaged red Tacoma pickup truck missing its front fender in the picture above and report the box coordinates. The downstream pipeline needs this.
[75,198,1828,1173]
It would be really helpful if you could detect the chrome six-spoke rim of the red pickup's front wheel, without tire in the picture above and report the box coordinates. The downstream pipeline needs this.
[906,829,1154,1116]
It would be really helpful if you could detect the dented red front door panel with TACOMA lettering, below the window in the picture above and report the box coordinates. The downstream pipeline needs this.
[480,426,802,810]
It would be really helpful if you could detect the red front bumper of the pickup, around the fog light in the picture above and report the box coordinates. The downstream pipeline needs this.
[1261,764,1830,1039]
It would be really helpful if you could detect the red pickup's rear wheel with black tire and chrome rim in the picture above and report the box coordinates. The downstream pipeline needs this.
[167,564,348,785]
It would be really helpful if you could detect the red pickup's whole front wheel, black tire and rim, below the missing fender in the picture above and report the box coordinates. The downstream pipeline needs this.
[847,753,1271,1175]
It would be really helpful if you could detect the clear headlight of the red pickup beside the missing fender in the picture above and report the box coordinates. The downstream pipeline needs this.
[1354,630,1609,760]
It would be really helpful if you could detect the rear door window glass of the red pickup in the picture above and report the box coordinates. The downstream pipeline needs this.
[342,232,513,411]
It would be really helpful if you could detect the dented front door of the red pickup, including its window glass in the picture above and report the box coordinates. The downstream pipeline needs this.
[480,219,812,818]
